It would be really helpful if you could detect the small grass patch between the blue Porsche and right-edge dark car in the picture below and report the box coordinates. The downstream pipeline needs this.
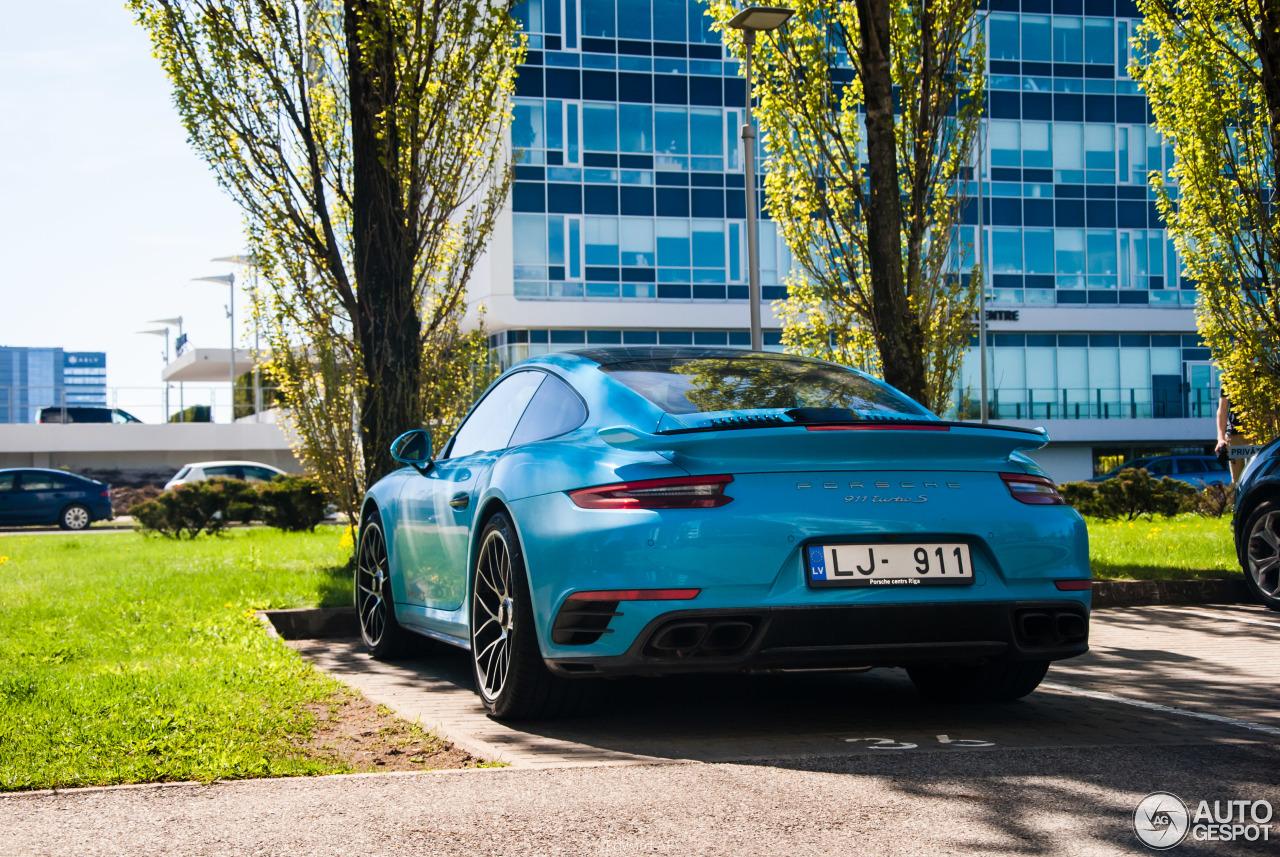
[1085,514,1240,581]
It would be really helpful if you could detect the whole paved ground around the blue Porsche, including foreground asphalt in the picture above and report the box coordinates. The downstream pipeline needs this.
[0,606,1280,857]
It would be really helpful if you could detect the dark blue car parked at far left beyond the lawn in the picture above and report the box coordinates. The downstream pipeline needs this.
[0,468,115,530]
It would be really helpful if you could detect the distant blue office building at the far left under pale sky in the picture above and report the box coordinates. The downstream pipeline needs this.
[0,345,106,423]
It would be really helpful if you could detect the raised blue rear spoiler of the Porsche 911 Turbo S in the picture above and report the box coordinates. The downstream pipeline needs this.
[596,420,1048,471]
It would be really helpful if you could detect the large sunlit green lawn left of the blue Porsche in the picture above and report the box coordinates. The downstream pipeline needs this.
[0,527,351,790]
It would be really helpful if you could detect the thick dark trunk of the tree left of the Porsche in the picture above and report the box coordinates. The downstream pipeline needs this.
[345,0,422,485]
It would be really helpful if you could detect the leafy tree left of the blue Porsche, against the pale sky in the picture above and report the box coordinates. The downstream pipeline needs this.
[128,0,524,510]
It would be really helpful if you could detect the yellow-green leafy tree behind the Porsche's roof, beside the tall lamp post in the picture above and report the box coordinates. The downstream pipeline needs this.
[710,0,986,411]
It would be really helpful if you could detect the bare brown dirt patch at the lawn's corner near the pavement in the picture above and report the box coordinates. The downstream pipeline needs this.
[297,693,480,773]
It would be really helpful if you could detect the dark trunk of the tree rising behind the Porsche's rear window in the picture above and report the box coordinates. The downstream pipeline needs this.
[856,0,927,402]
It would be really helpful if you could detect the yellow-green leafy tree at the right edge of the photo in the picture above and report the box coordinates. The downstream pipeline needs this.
[1129,0,1280,440]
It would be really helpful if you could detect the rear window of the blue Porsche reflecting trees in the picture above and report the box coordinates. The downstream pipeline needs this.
[600,356,932,418]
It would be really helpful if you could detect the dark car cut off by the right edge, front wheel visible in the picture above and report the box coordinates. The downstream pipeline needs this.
[1231,441,1280,610]
